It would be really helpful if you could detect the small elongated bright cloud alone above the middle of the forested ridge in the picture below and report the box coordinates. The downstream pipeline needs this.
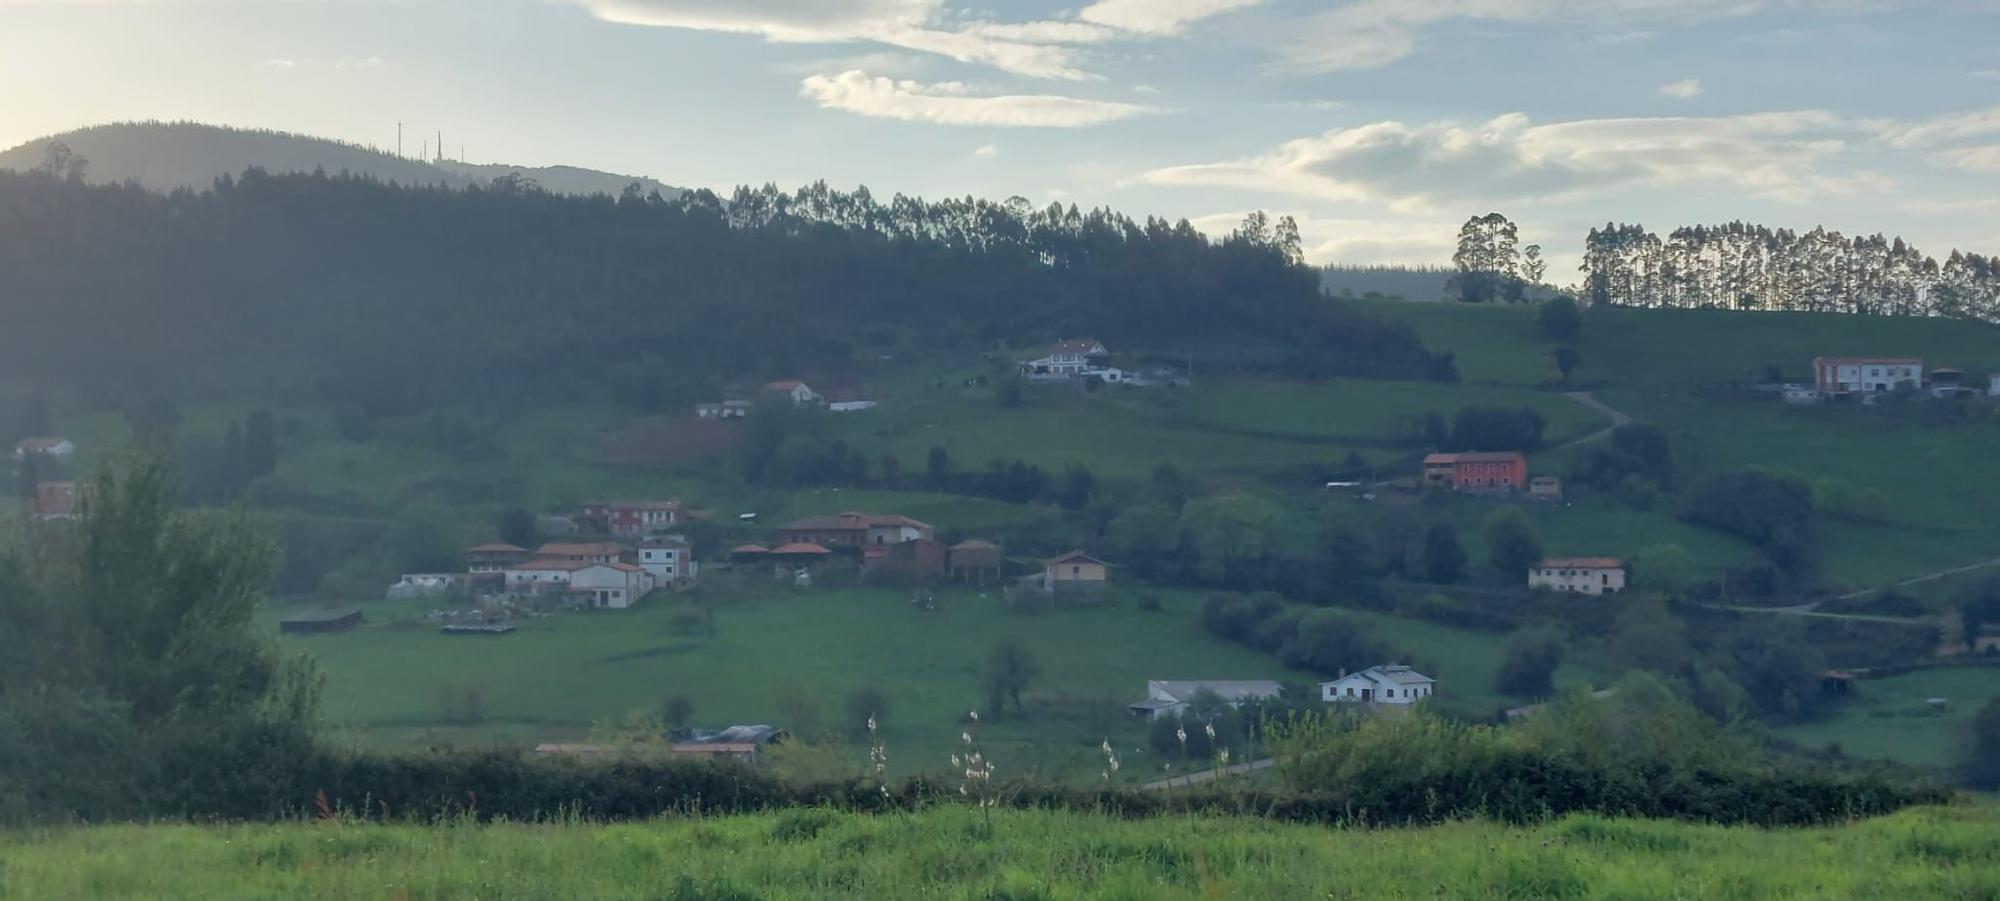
[800,70,1156,128]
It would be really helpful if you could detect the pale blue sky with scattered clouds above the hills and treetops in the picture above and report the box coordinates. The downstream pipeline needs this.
[0,0,2000,276]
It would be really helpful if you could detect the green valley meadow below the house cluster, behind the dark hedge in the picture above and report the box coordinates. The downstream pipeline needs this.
[284,589,1590,781]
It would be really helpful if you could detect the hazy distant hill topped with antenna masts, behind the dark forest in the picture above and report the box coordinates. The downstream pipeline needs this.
[0,122,680,198]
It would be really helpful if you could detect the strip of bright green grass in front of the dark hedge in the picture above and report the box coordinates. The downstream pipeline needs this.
[0,807,2000,899]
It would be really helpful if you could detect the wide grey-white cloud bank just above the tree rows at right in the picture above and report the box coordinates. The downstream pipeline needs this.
[1140,110,1882,210]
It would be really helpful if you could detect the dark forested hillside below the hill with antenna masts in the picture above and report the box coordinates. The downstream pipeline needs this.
[0,170,1452,408]
